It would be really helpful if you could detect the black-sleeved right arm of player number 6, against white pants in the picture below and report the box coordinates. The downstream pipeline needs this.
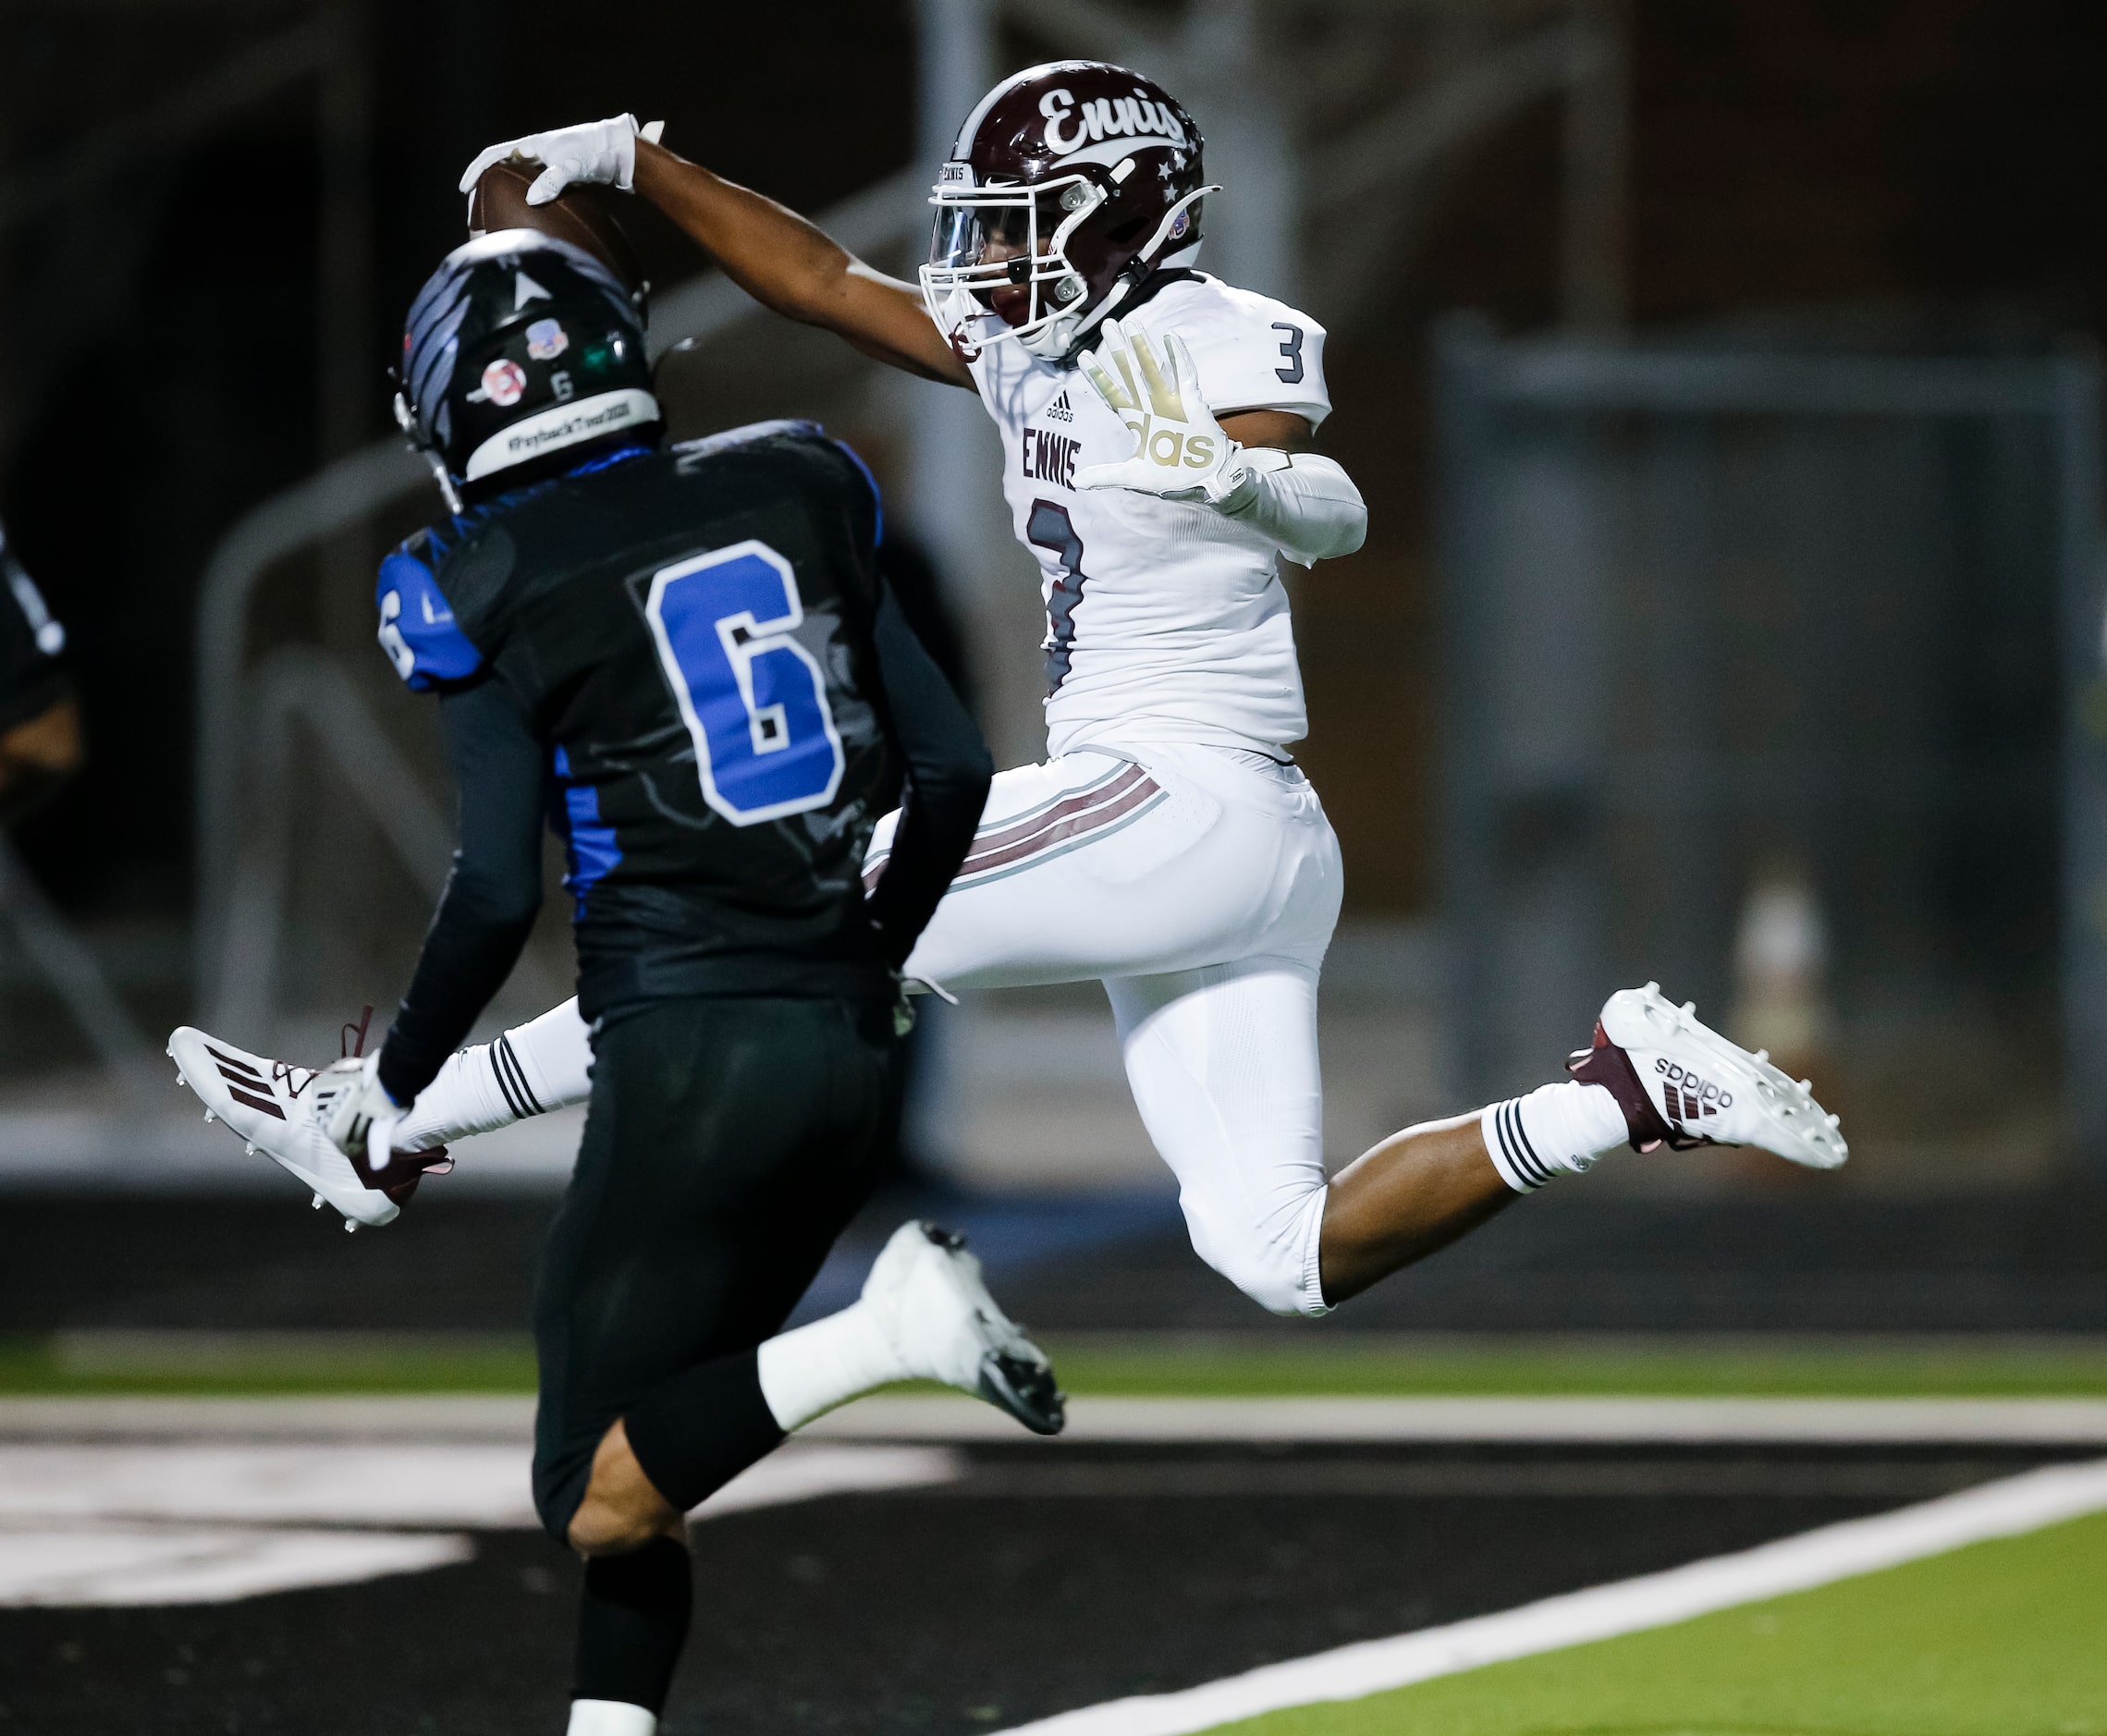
[866,583,995,967]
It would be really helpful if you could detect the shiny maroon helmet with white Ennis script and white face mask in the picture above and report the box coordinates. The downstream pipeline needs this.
[921,61,1218,361]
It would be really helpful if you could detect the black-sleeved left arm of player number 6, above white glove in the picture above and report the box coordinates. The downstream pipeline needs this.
[377,680,545,1108]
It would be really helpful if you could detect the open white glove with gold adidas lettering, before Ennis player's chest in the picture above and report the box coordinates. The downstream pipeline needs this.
[1074,320,1245,506]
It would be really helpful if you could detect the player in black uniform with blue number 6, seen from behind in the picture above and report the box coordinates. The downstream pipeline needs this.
[274,229,1062,1736]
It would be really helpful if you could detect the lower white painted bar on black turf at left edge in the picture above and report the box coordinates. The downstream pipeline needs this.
[0,1525,474,1609]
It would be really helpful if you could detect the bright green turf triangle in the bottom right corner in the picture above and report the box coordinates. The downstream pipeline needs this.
[1224,1515,2107,1736]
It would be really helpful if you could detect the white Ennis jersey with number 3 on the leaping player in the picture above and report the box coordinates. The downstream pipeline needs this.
[972,272,1331,754]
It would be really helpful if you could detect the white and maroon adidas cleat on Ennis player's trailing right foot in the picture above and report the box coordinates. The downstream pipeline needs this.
[1565,982,1850,1169]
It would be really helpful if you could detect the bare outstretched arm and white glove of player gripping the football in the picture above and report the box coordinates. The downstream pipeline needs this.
[461,114,974,387]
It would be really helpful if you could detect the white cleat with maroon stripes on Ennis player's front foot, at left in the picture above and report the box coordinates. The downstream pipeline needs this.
[168,1024,447,1230]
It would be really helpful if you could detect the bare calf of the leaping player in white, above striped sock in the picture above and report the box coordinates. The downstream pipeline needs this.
[1317,1115,1521,1302]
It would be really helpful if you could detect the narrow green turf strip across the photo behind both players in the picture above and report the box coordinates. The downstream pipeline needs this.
[0,1329,2107,1397]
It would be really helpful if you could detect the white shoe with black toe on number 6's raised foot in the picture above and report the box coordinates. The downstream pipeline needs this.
[864,1220,1068,1435]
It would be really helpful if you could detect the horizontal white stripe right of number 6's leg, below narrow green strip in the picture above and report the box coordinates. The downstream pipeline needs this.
[805,1397,2107,1445]
